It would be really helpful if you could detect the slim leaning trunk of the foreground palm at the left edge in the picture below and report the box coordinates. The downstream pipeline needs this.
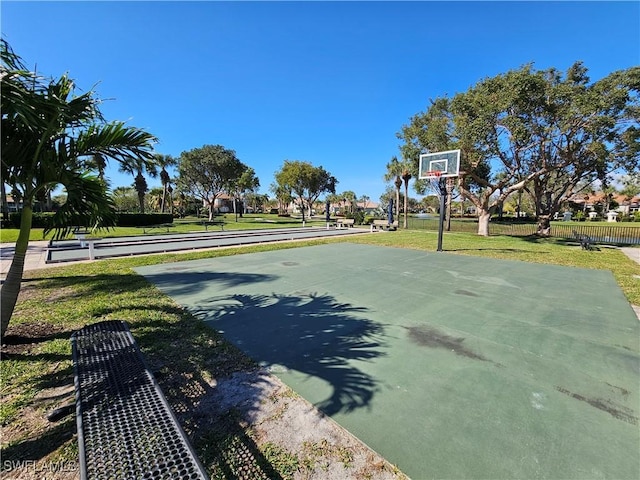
[0,202,33,343]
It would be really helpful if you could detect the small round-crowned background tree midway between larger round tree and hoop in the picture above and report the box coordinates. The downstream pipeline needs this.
[275,160,338,222]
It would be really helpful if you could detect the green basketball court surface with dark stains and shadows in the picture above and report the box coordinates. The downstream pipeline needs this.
[137,243,640,479]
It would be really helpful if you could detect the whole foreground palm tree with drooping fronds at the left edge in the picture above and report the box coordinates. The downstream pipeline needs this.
[0,40,156,339]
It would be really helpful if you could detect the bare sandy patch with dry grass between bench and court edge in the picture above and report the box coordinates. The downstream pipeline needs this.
[194,369,406,480]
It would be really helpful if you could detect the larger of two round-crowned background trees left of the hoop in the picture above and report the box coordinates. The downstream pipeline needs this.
[178,145,247,221]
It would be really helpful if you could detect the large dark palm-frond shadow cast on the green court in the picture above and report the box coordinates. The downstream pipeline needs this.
[191,293,384,415]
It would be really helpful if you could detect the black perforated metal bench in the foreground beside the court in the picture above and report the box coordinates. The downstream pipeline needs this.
[71,321,208,480]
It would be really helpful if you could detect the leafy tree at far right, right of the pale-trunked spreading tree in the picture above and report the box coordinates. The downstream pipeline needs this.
[525,63,640,235]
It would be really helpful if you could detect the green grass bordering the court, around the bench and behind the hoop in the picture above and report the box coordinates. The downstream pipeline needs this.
[0,231,640,478]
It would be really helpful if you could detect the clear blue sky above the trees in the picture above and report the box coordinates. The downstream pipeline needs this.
[0,0,640,201]
